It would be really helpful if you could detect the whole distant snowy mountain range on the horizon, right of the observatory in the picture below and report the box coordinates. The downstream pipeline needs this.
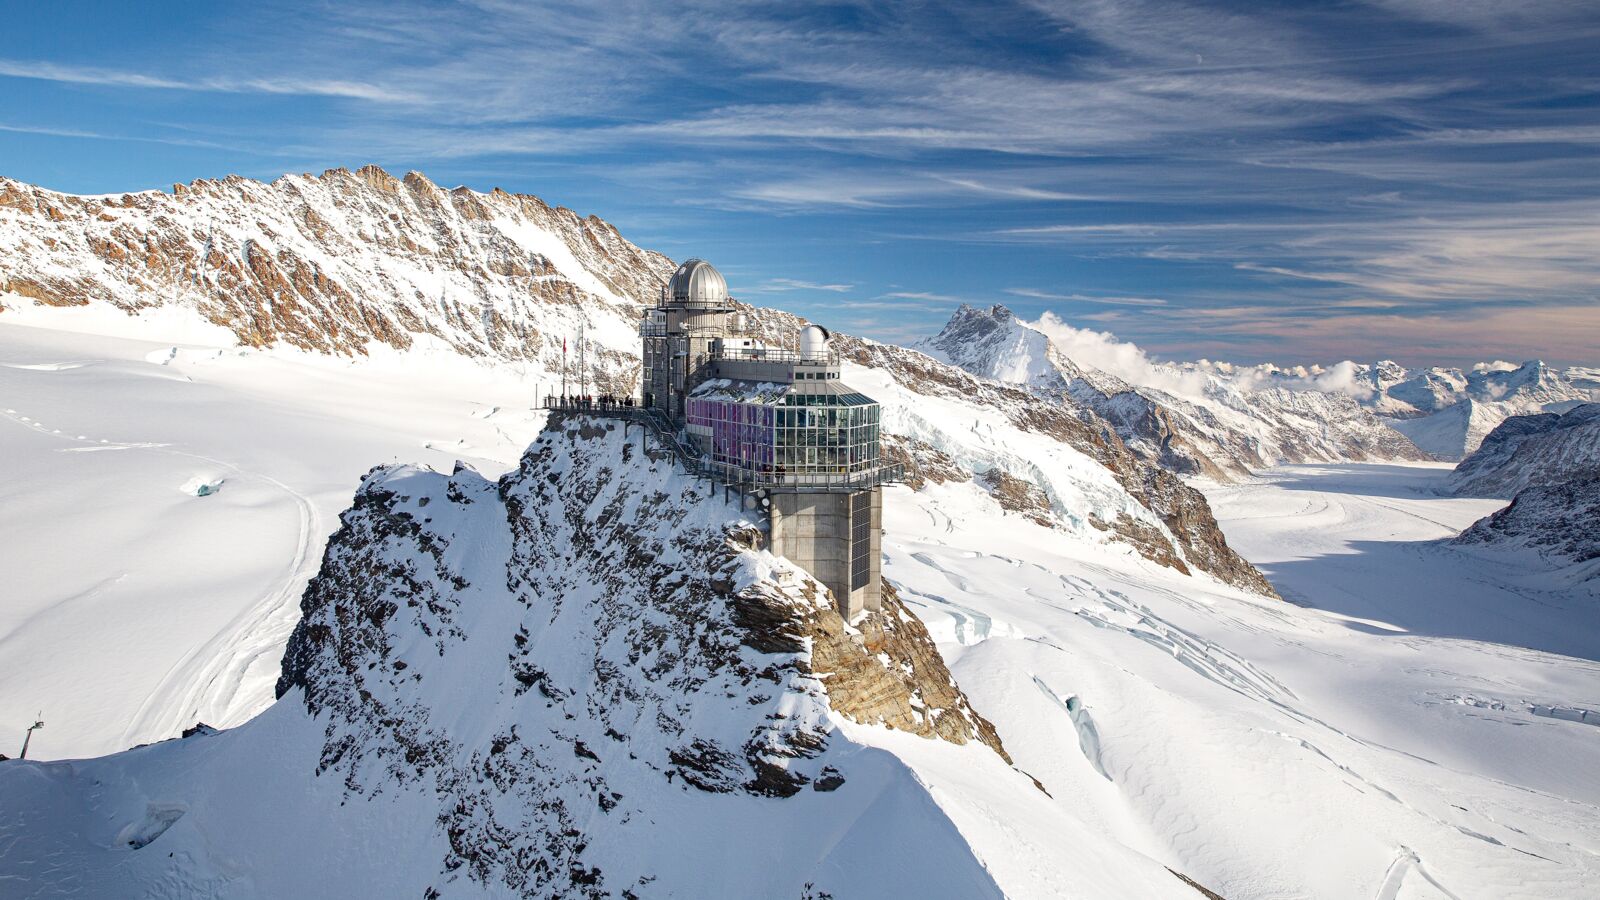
[915,306,1600,480]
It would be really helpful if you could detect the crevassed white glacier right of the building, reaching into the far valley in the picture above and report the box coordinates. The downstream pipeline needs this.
[885,466,1600,898]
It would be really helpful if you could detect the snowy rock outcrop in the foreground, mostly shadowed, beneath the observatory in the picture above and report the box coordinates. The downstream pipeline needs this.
[0,418,1194,898]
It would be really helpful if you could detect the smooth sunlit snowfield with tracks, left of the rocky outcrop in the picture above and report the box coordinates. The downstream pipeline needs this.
[0,307,552,757]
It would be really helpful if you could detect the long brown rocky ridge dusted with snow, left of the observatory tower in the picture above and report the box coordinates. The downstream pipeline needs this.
[0,167,672,391]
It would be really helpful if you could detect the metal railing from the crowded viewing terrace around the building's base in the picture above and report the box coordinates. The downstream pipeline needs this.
[544,397,906,493]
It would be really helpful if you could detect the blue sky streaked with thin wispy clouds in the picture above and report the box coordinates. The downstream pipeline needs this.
[0,0,1600,364]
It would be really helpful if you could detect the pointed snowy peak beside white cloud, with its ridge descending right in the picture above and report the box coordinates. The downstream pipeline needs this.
[918,306,1422,480]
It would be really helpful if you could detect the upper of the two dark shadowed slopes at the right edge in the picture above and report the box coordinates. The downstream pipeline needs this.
[1450,404,1600,496]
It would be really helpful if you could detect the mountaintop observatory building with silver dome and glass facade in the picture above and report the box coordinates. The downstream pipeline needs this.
[640,259,899,611]
